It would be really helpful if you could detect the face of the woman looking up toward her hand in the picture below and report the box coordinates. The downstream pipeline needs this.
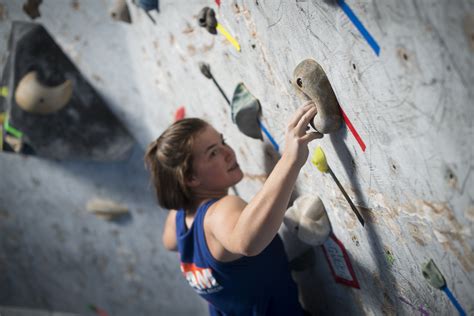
[188,125,243,193]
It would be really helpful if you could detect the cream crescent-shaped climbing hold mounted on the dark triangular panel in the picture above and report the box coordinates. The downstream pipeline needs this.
[15,71,72,114]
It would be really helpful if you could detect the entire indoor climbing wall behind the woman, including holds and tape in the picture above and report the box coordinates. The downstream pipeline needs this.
[0,0,474,315]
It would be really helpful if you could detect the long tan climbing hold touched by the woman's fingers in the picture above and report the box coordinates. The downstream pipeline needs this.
[292,59,342,134]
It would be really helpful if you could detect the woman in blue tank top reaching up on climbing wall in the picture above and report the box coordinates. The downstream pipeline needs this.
[145,105,322,316]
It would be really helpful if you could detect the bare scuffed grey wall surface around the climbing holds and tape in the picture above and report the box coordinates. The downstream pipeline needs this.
[0,0,474,315]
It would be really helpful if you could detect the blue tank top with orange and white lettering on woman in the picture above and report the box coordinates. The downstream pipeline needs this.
[176,200,303,316]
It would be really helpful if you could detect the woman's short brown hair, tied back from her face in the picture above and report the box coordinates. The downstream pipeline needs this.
[145,118,209,210]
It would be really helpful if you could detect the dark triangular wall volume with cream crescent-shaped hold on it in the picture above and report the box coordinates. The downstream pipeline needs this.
[0,21,135,161]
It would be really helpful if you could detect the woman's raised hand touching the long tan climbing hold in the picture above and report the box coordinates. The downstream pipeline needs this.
[283,103,323,168]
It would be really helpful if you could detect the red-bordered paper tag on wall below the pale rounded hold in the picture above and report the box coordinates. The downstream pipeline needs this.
[321,233,360,289]
